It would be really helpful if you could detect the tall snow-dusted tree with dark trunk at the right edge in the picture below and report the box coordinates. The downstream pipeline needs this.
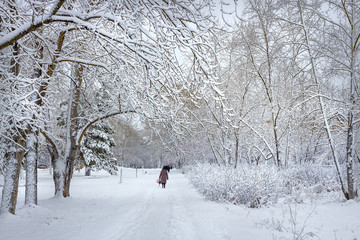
[321,0,360,199]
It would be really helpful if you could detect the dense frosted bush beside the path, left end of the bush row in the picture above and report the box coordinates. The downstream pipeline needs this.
[186,164,283,207]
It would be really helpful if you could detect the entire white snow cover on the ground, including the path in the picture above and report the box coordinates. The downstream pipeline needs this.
[0,169,360,240]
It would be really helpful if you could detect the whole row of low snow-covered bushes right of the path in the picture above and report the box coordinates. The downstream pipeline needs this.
[185,163,338,207]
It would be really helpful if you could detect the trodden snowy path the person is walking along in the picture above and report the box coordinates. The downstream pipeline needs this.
[90,170,265,240]
